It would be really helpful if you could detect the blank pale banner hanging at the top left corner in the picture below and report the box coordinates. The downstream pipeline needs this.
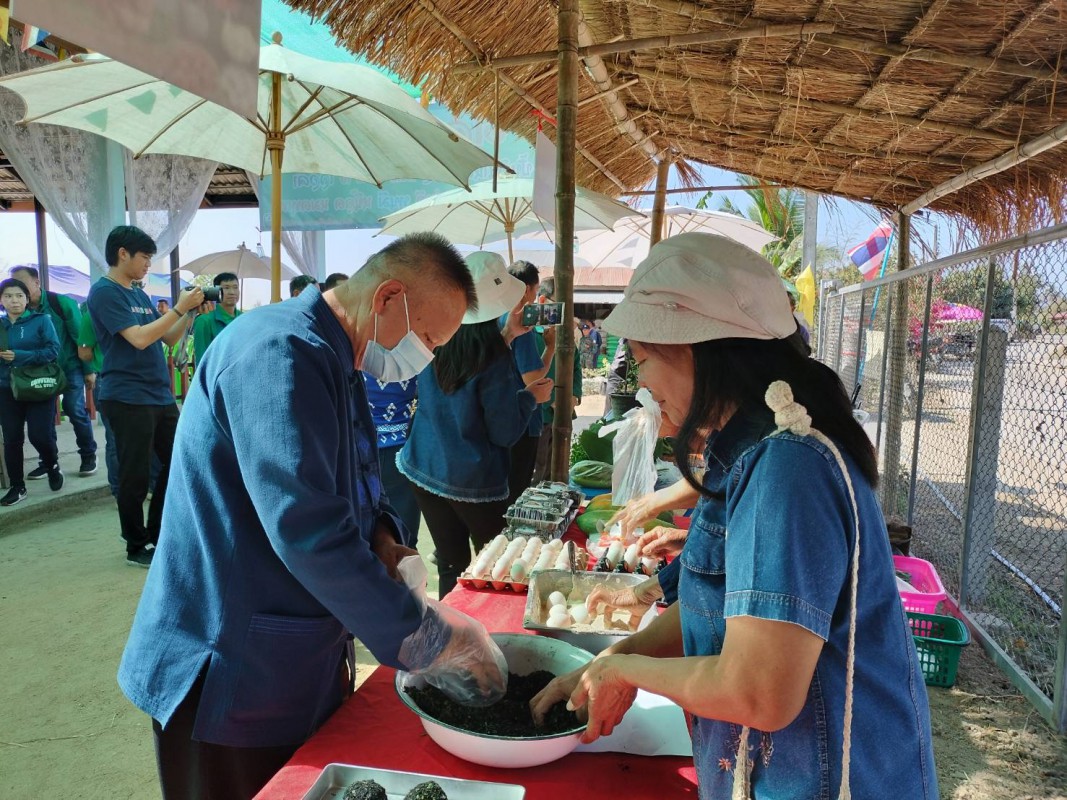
[12,0,261,119]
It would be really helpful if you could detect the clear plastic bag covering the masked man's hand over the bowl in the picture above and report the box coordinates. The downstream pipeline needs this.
[397,556,508,706]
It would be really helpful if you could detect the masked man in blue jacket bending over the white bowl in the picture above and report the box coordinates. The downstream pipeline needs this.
[118,234,503,800]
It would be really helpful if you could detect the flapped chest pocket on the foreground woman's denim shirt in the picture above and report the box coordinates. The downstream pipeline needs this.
[678,514,727,656]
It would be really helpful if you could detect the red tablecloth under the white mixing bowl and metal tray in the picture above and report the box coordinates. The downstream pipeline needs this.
[256,587,697,800]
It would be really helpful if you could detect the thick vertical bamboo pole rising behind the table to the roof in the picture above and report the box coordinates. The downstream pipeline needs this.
[550,0,579,481]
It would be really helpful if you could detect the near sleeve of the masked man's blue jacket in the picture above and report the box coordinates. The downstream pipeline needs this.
[210,339,421,666]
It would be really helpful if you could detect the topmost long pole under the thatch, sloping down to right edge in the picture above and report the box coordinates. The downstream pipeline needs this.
[631,0,1067,81]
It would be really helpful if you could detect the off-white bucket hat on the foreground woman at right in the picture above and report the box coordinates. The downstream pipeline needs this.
[604,234,797,345]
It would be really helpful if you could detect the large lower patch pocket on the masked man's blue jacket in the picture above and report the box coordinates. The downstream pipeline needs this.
[228,613,346,742]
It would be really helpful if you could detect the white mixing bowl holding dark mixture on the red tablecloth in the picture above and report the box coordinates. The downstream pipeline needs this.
[396,634,593,768]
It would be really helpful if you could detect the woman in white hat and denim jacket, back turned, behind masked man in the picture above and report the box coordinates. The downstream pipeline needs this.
[397,252,553,597]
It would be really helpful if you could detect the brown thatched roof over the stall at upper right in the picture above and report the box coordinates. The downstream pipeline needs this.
[287,0,1067,227]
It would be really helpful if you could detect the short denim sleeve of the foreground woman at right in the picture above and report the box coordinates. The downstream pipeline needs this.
[723,435,855,640]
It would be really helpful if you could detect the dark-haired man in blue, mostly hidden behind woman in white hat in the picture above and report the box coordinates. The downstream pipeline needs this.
[500,261,556,503]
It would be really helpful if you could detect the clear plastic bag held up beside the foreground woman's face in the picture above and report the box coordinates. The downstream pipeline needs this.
[600,388,663,506]
